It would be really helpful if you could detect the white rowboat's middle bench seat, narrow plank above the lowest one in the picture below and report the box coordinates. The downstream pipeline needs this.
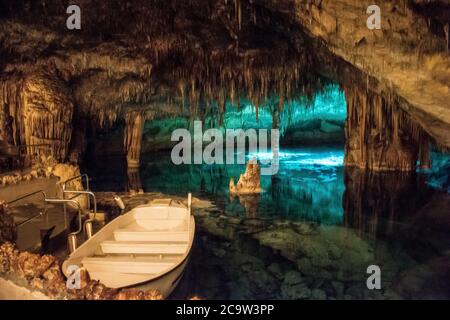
[100,241,188,255]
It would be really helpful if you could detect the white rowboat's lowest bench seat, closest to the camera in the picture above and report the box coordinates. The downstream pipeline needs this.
[81,255,179,274]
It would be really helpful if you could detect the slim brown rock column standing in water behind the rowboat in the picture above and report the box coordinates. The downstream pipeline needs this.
[124,111,145,168]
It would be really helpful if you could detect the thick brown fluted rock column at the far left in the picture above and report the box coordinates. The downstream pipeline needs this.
[0,70,73,160]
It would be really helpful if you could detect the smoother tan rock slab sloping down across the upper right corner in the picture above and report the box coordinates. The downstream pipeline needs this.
[284,0,450,148]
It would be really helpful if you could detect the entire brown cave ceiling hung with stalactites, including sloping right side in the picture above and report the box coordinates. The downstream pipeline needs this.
[0,0,450,147]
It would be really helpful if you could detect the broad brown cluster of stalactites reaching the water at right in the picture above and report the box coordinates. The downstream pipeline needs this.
[344,86,429,171]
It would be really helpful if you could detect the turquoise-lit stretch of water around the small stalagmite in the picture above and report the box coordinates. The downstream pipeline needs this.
[141,147,344,224]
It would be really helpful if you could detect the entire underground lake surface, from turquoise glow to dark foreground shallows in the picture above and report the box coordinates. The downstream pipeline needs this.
[88,147,450,299]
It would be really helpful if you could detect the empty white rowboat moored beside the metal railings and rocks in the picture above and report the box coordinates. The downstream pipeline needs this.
[62,199,195,298]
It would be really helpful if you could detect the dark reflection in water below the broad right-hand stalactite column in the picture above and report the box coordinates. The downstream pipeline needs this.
[343,168,435,238]
